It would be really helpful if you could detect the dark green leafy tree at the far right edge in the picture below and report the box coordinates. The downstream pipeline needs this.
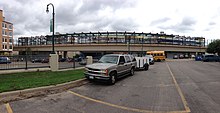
[206,39,220,56]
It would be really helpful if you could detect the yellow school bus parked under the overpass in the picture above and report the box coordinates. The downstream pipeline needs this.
[147,51,166,62]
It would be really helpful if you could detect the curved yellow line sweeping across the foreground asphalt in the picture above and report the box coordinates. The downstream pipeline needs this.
[68,90,188,113]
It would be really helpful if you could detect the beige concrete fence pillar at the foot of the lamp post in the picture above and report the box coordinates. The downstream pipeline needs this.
[50,54,59,71]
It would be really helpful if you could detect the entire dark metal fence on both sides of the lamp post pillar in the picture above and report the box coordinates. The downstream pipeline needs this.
[0,55,98,70]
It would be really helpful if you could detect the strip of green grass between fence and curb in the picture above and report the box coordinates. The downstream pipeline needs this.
[0,69,84,93]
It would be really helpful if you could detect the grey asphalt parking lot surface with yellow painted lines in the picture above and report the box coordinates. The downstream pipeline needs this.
[0,60,220,113]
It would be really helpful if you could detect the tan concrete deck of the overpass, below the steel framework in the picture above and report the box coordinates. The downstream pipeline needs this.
[14,44,206,57]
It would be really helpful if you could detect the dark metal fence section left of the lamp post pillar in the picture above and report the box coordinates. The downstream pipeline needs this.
[0,55,50,70]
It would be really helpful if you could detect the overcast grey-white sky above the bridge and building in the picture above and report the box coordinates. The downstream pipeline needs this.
[0,0,220,39]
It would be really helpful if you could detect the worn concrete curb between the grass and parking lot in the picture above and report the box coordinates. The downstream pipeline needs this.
[0,78,88,104]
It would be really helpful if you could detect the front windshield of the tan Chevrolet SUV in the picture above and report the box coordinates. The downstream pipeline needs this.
[99,55,118,64]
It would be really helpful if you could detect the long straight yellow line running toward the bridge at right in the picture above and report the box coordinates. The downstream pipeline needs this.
[166,62,191,112]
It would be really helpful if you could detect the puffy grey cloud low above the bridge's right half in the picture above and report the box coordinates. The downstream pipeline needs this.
[159,17,196,33]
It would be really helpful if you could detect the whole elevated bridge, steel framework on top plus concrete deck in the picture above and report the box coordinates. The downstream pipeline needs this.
[14,31,206,58]
